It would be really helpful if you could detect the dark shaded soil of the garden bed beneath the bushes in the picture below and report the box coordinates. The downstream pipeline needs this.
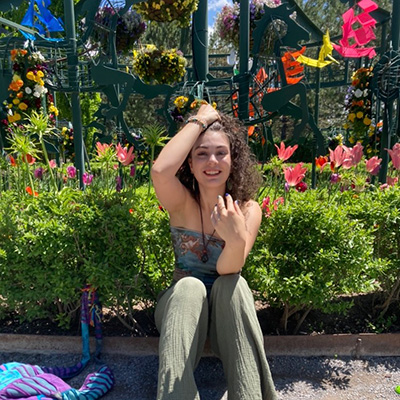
[0,294,400,337]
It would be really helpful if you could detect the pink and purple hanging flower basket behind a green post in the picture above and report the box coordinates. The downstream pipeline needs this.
[214,0,284,55]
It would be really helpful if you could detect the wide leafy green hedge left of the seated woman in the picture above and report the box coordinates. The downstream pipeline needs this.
[0,188,173,329]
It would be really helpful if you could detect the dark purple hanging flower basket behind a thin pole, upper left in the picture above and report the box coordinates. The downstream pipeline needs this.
[92,6,146,54]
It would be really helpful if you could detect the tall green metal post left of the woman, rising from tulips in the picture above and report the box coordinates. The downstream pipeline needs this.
[64,0,85,189]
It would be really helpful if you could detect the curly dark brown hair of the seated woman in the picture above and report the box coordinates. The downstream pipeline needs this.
[177,113,262,202]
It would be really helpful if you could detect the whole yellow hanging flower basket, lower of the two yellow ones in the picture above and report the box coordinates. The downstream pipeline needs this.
[133,45,186,85]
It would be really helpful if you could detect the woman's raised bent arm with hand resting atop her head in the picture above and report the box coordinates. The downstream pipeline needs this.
[151,104,219,212]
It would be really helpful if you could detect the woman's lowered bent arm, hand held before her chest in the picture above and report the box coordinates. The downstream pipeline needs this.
[211,195,262,275]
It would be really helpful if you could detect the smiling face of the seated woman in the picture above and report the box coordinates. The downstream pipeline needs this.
[189,130,231,190]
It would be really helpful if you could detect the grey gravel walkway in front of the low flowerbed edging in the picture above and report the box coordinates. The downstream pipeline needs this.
[0,352,400,400]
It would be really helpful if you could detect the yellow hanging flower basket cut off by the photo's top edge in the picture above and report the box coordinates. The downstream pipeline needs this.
[134,0,199,27]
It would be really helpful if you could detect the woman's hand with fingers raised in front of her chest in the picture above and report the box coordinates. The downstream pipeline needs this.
[211,194,247,244]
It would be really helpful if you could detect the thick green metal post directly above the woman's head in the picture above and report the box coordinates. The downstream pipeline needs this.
[193,0,208,81]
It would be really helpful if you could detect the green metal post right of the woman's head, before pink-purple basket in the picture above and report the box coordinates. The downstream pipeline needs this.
[239,0,250,121]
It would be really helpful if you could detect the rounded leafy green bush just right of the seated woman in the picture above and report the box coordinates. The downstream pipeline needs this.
[245,191,380,331]
